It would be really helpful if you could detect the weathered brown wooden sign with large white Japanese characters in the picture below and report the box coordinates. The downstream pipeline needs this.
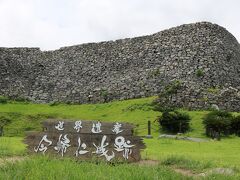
[25,120,145,162]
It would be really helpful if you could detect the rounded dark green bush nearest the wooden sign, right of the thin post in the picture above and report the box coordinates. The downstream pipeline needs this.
[158,111,191,133]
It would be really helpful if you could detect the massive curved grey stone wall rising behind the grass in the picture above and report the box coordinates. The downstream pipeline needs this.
[0,22,240,111]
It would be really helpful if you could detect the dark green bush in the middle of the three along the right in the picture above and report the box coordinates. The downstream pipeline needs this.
[203,111,233,139]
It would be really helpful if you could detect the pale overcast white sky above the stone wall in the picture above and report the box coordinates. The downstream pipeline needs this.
[0,0,240,50]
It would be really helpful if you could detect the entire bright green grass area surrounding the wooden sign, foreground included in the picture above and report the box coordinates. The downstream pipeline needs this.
[0,97,240,179]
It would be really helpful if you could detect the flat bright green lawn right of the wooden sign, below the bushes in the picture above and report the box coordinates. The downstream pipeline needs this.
[142,137,240,167]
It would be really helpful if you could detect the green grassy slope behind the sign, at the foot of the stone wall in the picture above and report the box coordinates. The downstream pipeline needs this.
[0,97,207,137]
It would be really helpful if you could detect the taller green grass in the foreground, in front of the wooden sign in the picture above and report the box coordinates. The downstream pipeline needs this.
[0,156,190,180]
